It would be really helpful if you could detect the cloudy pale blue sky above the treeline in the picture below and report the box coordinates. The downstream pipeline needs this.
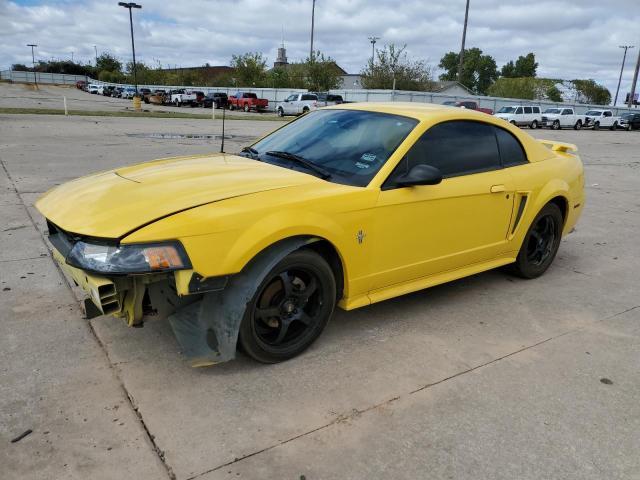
[0,0,640,100]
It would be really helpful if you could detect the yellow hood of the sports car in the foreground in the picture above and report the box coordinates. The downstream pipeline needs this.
[36,154,322,238]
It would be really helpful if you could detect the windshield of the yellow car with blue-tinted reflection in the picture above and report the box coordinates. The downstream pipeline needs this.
[245,110,418,186]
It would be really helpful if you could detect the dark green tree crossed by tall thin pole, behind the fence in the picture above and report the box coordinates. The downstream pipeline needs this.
[438,48,498,95]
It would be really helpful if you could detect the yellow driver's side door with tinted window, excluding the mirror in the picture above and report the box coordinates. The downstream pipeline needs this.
[370,121,514,290]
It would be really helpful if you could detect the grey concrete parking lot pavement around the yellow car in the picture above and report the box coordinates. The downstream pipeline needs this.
[0,104,640,480]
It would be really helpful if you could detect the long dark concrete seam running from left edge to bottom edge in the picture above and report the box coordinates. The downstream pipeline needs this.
[0,159,176,480]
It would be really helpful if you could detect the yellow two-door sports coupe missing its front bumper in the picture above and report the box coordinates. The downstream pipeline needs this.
[36,103,584,366]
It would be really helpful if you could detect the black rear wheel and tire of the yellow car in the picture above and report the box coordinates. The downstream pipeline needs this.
[512,203,564,278]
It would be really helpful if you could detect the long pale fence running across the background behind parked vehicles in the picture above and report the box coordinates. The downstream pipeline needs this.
[0,70,637,115]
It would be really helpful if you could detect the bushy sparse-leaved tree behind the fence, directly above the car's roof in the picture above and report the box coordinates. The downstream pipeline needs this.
[360,43,433,91]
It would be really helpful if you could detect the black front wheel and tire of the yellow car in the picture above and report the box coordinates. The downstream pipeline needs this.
[238,249,336,363]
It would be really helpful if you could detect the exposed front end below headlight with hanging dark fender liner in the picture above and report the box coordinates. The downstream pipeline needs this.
[50,223,310,367]
